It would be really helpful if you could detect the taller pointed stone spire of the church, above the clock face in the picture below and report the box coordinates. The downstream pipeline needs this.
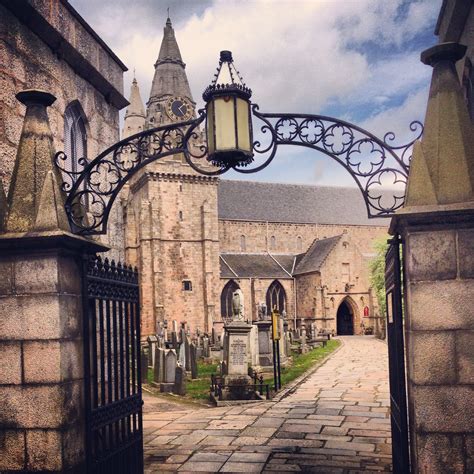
[147,17,194,126]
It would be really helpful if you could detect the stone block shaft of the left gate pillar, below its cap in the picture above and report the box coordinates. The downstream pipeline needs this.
[0,246,84,472]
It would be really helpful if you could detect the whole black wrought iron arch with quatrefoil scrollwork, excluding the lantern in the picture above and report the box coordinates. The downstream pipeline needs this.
[55,104,423,235]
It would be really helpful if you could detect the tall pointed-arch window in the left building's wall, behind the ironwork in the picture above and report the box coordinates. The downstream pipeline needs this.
[64,101,87,172]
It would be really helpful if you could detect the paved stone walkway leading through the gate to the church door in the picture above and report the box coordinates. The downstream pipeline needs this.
[144,336,391,473]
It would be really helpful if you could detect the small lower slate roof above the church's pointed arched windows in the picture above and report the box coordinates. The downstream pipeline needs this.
[220,253,294,278]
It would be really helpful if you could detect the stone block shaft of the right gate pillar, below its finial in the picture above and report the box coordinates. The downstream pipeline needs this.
[404,219,474,473]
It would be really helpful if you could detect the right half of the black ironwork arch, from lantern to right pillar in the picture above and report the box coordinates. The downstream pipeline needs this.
[241,104,423,218]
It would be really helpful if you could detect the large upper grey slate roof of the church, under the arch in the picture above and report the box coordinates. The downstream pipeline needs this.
[217,179,389,226]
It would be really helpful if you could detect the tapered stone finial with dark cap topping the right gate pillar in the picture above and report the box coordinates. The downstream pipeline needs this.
[405,43,474,211]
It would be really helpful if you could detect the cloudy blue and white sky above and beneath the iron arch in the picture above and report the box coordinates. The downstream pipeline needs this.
[70,0,441,186]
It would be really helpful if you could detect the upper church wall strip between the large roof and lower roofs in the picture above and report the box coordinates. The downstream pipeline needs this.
[219,219,389,254]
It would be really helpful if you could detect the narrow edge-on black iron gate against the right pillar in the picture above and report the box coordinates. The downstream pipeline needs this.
[385,236,410,473]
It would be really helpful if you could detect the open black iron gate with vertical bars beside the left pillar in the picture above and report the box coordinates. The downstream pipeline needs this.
[83,256,143,474]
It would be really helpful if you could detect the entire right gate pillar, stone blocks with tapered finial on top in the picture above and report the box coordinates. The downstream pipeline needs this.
[391,43,474,474]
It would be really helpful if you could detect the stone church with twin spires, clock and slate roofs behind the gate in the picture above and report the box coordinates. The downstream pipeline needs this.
[122,18,387,336]
